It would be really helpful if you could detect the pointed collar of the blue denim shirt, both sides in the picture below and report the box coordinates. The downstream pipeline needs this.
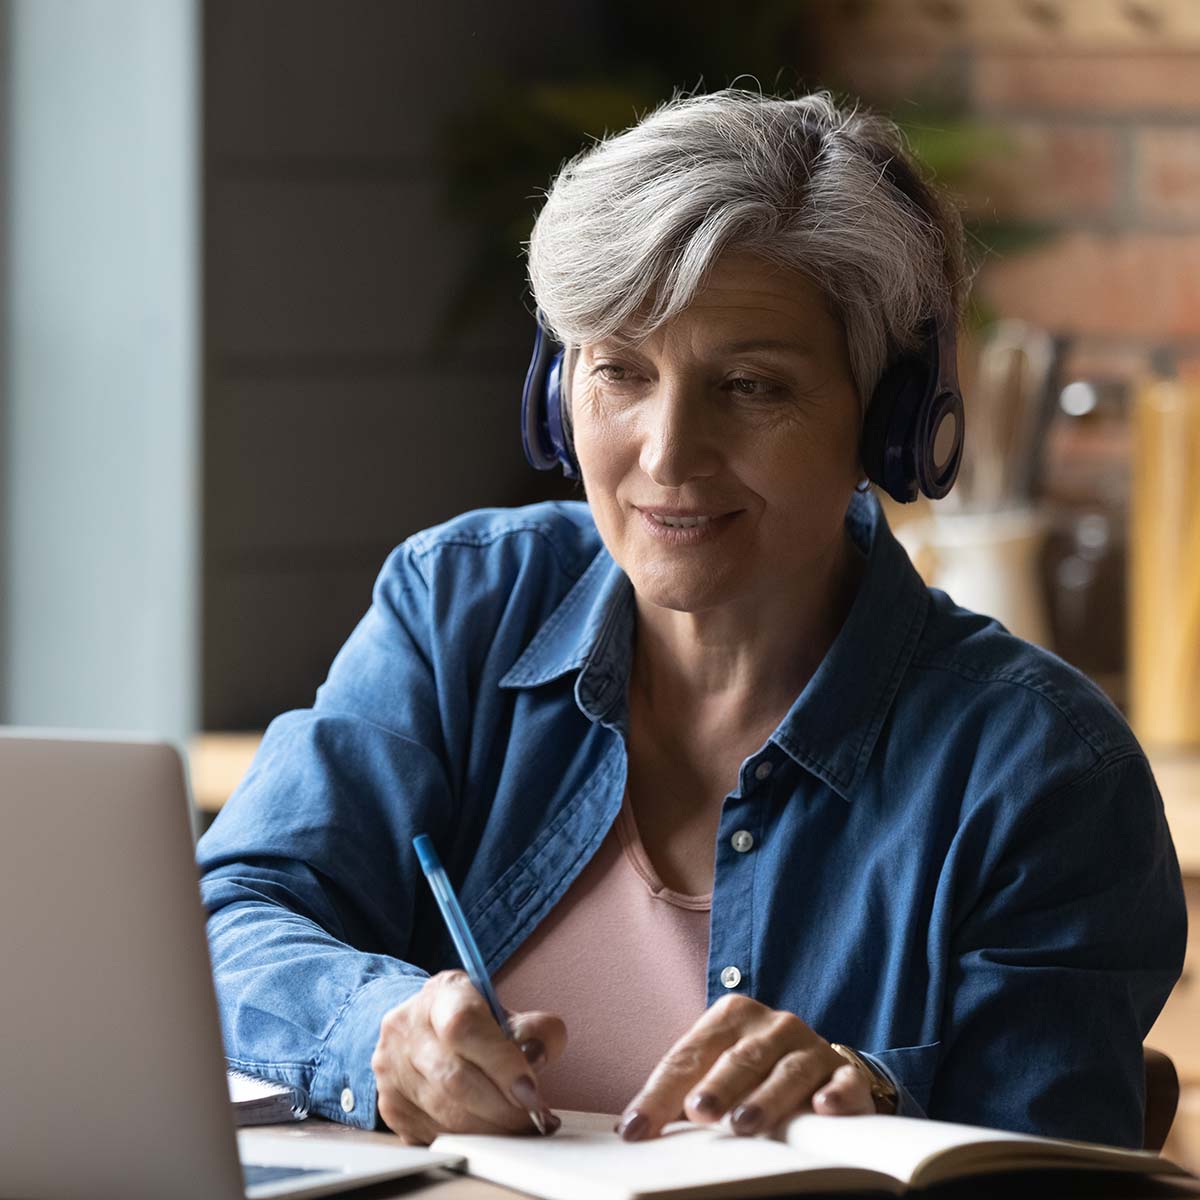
[500,493,929,800]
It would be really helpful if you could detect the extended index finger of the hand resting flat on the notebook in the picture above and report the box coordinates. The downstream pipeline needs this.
[617,996,774,1141]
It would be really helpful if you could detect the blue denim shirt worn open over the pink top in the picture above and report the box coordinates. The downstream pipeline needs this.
[198,496,1186,1146]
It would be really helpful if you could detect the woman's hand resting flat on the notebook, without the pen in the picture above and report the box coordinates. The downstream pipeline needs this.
[617,996,876,1141]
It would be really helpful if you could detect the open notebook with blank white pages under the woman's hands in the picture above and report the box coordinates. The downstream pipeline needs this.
[433,1112,1188,1200]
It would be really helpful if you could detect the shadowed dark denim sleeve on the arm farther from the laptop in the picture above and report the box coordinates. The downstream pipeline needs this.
[928,751,1187,1147]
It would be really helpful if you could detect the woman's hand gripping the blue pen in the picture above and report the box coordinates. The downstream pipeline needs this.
[371,971,566,1146]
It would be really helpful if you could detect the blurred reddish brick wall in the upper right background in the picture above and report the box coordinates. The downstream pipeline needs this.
[816,0,1200,373]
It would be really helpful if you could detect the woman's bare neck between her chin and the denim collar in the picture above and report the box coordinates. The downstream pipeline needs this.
[630,534,865,734]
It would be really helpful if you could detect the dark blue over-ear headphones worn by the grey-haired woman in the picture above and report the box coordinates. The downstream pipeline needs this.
[521,312,964,504]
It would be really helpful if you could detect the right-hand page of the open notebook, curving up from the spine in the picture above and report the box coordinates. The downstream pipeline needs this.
[782,1114,1182,1186]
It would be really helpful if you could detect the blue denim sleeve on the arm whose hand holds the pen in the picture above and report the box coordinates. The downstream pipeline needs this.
[197,547,455,1128]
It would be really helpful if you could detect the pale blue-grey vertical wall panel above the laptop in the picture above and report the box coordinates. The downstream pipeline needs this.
[0,0,200,736]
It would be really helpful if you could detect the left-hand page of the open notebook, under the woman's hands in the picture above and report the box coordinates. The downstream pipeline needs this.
[433,1112,900,1200]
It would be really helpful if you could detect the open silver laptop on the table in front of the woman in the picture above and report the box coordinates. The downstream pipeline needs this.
[0,730,461,1200]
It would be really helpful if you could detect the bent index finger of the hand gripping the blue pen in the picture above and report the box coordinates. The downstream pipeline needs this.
[427,972,545,1132]
